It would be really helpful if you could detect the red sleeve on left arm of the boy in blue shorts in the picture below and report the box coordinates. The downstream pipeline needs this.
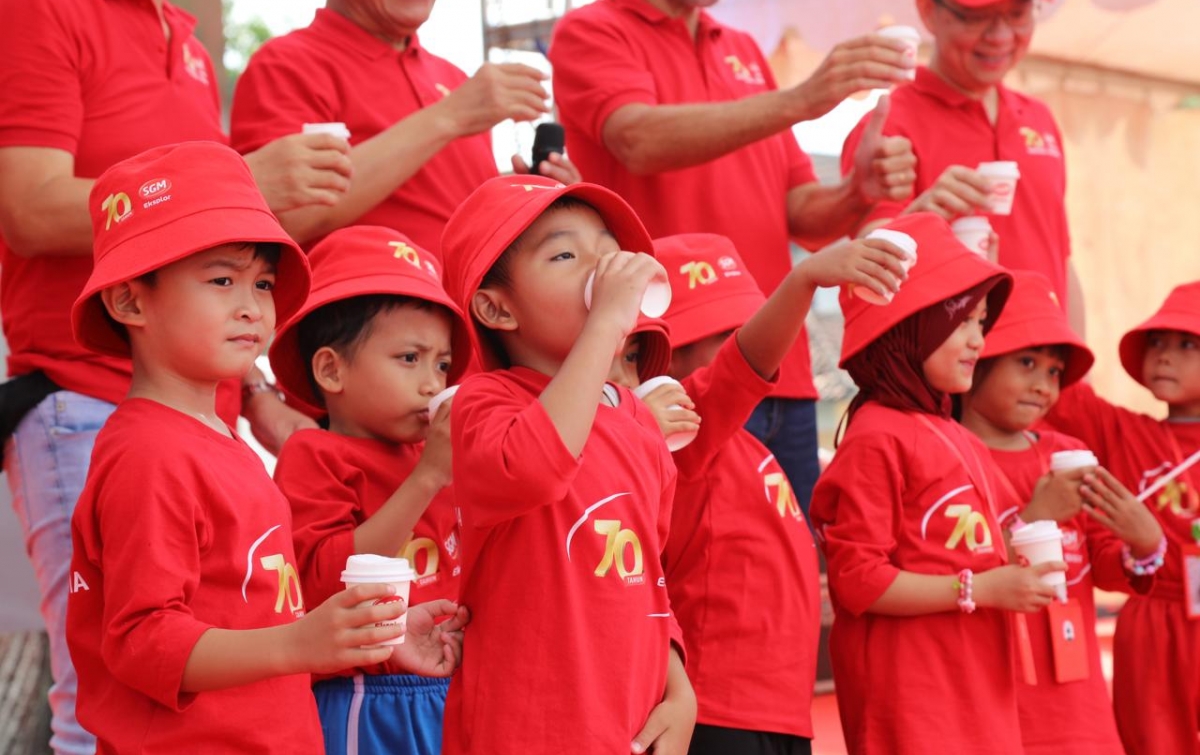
[275,430,361,605]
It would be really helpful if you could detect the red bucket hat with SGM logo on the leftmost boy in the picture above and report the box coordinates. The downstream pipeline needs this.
[71,142,310,358]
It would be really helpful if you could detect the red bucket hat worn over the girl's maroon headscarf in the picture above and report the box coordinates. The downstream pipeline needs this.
[838,212,1013,367]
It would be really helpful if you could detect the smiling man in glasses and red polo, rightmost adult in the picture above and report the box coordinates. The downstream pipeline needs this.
[842,0,1084,332]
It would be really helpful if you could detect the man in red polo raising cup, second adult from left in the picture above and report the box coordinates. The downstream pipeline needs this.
[232,0,578,252]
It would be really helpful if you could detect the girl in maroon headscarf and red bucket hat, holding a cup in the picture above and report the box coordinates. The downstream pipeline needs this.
[810,212,1066,755]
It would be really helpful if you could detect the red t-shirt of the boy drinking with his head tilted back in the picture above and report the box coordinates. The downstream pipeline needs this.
[443,367,676,755]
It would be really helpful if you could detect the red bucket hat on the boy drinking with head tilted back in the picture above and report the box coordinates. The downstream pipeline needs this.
[442,175,654,370]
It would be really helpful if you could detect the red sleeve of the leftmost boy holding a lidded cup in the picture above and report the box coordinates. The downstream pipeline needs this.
[96,449,213,711]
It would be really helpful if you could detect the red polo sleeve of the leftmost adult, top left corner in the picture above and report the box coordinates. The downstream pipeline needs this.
[0,0,84,155]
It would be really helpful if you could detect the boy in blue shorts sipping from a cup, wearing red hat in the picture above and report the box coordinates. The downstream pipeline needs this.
[271,226,470,755]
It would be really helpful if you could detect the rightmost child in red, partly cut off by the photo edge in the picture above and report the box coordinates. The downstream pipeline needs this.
[1046,282,1200,755]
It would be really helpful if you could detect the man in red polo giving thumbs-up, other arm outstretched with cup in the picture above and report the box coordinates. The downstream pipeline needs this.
[550,0,912,509]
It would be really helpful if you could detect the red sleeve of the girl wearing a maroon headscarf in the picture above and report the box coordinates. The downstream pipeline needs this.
[812,435,904,616]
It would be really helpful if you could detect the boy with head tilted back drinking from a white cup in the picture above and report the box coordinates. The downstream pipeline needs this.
[442,175,695,755]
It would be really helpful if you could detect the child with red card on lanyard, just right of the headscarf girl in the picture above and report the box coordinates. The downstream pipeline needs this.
[962,271,1163,755]
